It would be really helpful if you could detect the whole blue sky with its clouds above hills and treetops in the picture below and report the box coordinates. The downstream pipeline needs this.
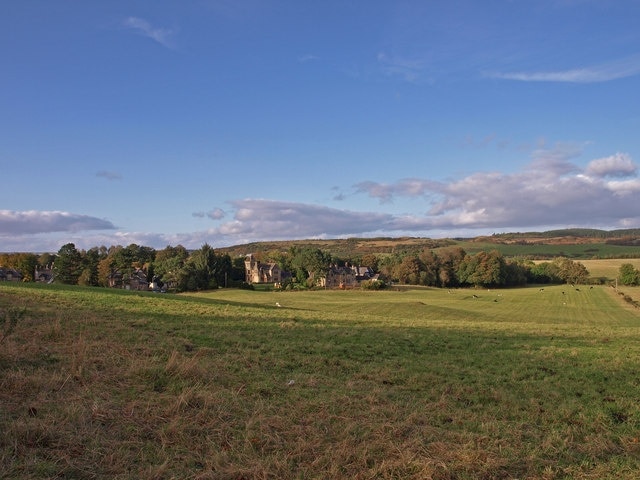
[0,0,640,252]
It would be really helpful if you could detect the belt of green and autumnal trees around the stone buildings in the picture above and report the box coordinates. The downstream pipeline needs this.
[0,243,589,292]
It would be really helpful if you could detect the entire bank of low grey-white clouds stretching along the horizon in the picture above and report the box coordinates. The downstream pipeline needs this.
[0,150,640,251]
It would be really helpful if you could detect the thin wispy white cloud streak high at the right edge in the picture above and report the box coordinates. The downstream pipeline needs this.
[485,55,640,83]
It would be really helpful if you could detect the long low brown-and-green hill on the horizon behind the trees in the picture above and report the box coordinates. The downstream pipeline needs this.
[216,228,640,258]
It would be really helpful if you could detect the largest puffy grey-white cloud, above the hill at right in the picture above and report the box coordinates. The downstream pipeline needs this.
[356,149,640,230]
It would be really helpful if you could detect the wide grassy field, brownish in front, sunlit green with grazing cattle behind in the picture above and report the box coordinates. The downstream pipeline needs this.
[0,284,640,480]
